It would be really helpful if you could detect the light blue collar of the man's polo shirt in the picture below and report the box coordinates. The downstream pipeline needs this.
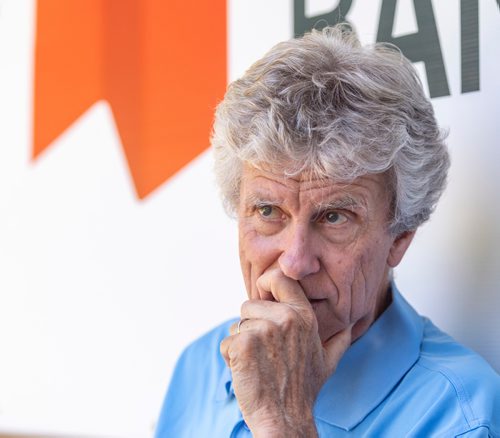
[216,284,423,430]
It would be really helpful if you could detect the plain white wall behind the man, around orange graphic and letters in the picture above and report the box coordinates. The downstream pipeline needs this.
[0,0,500,438]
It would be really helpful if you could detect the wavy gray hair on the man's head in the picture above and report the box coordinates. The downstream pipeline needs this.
[212,26,449,234]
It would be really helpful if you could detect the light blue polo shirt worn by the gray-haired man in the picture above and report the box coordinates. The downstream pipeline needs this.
[156,286,500,438]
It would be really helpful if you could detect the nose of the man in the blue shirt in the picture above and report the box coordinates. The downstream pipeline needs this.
[278,225,320,280]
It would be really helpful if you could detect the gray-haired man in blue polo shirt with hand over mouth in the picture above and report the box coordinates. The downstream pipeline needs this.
[156,27,500,438]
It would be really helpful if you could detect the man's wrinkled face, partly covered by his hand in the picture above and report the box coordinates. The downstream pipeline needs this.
[238,165,413,341]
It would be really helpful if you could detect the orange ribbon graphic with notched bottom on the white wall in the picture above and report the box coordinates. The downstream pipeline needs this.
[33,0,226,198]
